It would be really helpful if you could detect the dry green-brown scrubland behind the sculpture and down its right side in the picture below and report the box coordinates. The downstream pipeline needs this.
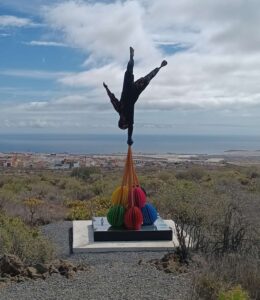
[0,165,260,300]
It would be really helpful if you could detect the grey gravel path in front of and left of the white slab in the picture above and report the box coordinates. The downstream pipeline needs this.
[0,222,190,300]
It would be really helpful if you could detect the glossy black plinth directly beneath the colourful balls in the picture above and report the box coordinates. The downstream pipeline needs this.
[92,217,172,242]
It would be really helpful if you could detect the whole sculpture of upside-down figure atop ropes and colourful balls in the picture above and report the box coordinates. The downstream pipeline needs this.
[103,47,171,232]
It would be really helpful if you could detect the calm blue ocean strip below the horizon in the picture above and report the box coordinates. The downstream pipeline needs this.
[0,134,260,154]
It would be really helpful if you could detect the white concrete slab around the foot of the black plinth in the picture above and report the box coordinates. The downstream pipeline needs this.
[72,220,178,253]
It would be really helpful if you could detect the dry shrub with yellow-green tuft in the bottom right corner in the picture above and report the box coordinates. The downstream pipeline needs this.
[192,253,260,300]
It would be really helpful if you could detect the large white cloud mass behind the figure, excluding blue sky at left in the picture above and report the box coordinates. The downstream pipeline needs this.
[0,0,260,134]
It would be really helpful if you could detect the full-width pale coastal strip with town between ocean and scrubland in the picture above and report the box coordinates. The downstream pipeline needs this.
[0,150,260,170]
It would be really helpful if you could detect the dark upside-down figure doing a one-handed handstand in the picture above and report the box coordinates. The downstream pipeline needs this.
[103,47,167,146]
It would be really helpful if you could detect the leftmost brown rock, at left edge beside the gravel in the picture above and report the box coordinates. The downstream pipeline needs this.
[0,254,24,276]
